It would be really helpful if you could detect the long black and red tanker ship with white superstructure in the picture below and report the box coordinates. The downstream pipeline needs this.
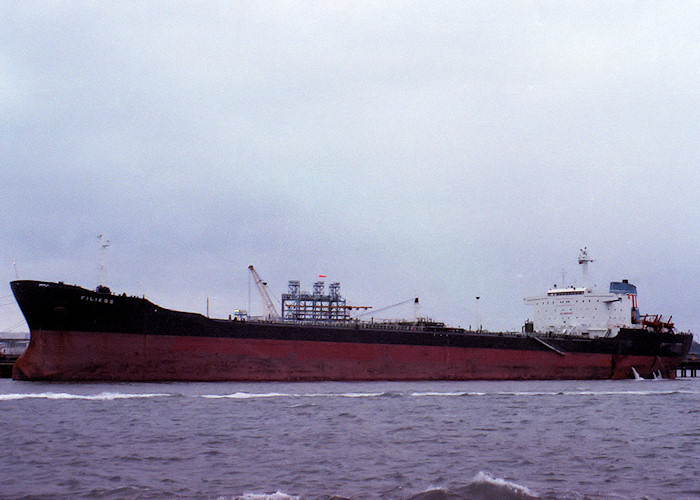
[11,251,692,381]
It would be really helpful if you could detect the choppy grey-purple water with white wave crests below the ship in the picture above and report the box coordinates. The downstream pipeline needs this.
[0,378,700,500]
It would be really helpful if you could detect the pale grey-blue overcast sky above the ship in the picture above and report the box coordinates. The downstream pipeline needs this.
[0,0,700,334]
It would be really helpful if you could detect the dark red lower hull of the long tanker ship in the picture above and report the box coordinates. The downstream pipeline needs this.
[12,331,680,381]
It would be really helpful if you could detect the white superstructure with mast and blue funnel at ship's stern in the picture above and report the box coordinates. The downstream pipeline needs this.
[525,249,640,337]
